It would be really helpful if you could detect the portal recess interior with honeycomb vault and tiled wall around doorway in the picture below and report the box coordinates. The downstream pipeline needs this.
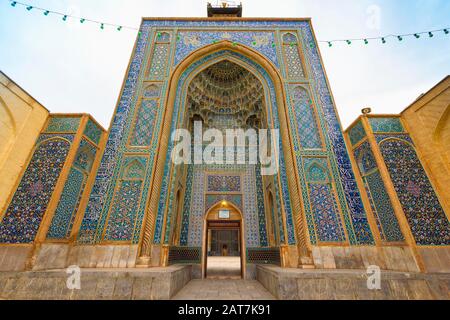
[172,58,276,255]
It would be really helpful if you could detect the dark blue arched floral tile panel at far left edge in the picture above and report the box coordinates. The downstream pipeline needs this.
[0,136,70,243]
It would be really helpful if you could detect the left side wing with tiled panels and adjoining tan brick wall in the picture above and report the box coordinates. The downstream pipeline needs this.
[0,73,106,271]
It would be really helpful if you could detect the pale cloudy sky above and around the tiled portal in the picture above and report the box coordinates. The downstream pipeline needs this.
[0,0,450,128]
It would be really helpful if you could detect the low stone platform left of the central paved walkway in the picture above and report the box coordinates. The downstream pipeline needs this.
[0,266,192,300]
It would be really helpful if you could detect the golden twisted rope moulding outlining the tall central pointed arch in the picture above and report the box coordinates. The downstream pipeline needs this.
[140,40,309,257]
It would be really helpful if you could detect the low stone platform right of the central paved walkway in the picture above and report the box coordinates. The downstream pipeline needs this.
[257,266,450,300]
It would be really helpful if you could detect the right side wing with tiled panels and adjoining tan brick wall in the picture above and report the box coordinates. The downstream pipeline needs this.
[345,76,450,272]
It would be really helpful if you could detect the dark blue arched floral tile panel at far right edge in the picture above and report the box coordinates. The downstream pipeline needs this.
[380,139,450,245]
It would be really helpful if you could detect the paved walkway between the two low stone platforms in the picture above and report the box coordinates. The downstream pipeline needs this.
[173,279,275,300]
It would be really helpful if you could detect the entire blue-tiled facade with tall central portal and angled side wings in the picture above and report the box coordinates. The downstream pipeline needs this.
[0,13,450,278]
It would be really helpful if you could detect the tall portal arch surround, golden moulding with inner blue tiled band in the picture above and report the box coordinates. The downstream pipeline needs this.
[139,41,309,270]
